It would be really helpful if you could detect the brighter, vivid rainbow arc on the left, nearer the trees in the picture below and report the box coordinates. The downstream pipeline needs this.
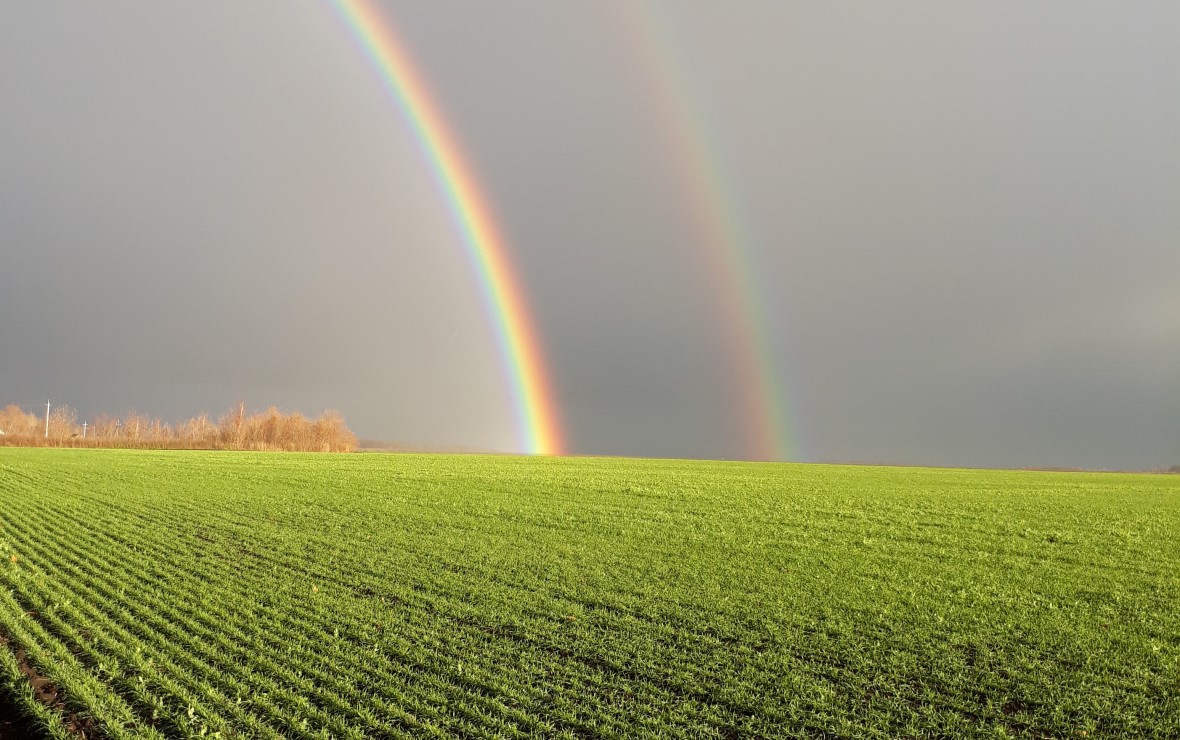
[328,0,563,454]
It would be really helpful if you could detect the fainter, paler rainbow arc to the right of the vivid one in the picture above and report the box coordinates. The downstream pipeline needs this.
[611,0,793,460]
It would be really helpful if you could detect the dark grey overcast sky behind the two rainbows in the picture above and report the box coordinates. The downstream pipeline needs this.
[0,0,1180,467]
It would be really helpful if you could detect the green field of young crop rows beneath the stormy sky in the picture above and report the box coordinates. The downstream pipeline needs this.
[0,450,1180,738]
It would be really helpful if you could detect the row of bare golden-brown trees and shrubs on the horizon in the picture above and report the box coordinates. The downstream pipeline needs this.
[0,404,356,452]
